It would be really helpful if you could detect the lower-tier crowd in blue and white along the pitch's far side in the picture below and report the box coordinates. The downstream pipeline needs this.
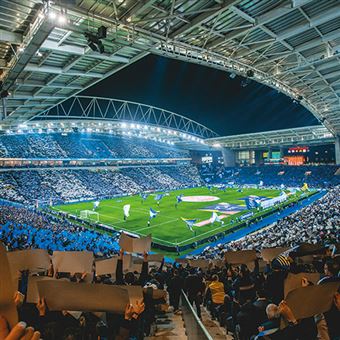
[0,165,202,204]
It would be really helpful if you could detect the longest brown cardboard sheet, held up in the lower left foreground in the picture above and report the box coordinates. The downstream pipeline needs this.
[37,280,129,314]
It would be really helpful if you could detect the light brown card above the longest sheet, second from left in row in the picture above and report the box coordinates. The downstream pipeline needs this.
[52,251,93,274]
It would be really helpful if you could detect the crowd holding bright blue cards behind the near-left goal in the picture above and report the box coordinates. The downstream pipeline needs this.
[0,202,119,256]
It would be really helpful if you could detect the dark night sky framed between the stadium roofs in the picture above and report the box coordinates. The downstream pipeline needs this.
[83,55,318,135]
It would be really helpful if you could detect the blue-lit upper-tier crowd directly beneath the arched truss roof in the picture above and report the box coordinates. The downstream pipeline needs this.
[0,132,188,159]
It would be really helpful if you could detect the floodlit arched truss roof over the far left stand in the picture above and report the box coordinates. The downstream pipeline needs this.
[0,96,218,150]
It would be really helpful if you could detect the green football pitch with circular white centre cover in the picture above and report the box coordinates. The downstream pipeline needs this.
[53,187,301,246]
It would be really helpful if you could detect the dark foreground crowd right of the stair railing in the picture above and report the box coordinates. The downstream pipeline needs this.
[178,246,340,340]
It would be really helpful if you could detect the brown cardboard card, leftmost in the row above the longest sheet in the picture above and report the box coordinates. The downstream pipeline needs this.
[7,249,51,279]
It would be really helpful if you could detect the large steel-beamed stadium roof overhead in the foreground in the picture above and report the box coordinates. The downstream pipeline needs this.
[0,0,340,134]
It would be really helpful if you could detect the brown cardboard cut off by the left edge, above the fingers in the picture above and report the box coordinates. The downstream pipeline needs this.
[0,242,18,328]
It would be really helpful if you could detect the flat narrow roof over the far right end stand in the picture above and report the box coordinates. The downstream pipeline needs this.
[205,126,335,149]
